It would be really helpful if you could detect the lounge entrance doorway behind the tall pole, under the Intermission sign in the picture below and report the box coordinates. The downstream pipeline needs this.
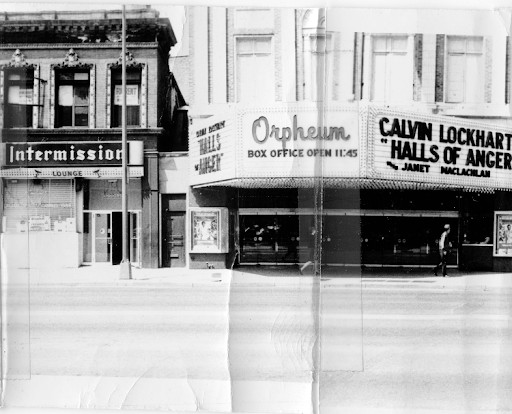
[83,211,140,266]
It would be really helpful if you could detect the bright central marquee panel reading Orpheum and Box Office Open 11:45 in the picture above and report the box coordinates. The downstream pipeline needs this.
[237,104,360,178]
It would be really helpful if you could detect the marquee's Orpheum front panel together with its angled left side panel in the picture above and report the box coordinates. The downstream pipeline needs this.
[189,103,361,185]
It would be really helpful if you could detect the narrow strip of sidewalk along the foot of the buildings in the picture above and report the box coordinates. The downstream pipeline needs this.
[2,265,512,288]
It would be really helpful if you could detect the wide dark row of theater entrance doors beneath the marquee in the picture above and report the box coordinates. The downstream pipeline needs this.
[239,209,459,267]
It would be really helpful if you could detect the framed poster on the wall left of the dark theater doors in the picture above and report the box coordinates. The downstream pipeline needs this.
[190,207,227,253]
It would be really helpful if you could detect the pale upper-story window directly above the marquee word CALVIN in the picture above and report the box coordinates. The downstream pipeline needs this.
[370,35,413,102]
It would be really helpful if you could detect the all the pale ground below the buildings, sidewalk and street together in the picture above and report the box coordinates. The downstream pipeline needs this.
[2,266,512,414]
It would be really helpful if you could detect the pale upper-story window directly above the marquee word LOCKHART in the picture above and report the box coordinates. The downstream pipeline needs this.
[445,36,485,103]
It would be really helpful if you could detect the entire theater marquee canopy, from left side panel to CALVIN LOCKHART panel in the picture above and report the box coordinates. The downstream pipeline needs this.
[189,103,512,192]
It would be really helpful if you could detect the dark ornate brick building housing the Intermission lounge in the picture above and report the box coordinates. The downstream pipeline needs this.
[0,7,184,267]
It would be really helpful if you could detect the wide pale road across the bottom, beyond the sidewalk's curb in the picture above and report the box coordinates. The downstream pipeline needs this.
[3,280,512,414]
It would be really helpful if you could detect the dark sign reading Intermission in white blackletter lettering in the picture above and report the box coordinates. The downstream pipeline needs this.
[3,142,123,167]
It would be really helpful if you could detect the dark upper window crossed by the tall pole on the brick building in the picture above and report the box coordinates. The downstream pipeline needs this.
[111,68,142,127]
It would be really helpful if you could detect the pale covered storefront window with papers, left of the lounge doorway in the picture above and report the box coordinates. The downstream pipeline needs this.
[3,179,76,233]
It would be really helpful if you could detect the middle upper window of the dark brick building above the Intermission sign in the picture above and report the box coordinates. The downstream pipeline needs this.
[55,69,90,127]
